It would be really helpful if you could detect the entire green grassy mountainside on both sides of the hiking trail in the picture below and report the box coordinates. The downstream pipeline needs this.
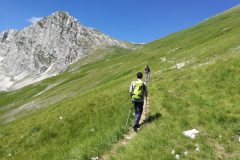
[0,7,240,160]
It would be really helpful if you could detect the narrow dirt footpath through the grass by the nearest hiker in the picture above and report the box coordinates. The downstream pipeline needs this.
[99,99,149,160]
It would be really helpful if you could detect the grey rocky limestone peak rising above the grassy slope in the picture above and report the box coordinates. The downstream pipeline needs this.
[0,12,126,91]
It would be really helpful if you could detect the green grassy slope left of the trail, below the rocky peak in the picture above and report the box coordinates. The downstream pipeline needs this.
[0,48,138,159]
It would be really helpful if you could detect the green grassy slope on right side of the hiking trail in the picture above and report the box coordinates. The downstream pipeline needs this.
[112,7,240,160]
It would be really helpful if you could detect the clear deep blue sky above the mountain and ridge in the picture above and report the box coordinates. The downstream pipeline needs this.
[0,0,240,43]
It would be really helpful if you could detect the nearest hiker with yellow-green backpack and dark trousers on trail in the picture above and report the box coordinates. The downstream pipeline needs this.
[129,72,148,132]
